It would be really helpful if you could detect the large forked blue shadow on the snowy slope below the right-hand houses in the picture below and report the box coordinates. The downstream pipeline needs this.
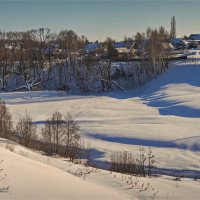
[105,62,200,118]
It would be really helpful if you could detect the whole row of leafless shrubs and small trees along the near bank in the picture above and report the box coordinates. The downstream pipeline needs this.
[0,100,157,177]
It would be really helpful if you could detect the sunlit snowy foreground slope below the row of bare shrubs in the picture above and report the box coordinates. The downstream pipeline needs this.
[0,139,200,200]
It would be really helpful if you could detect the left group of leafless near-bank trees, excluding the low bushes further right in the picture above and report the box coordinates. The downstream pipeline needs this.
[0,100,83,162]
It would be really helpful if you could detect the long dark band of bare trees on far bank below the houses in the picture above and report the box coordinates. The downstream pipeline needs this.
[0,18,175,93]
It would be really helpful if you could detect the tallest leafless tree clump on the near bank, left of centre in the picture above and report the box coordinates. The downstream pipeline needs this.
[42,111,80,162]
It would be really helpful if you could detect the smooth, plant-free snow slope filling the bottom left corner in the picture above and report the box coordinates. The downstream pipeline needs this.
[0,143,123,199]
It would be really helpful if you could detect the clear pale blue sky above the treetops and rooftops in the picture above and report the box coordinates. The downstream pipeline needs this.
[0,0,200,41]
